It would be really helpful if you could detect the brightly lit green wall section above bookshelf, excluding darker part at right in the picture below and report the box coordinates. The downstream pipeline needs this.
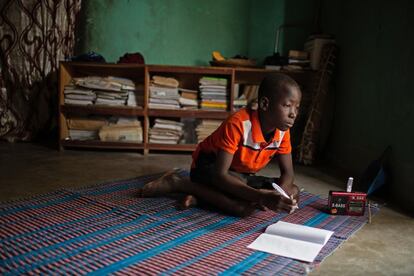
[77,0,250,65]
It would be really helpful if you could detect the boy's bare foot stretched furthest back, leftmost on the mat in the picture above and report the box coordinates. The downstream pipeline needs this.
[138,169,183,197]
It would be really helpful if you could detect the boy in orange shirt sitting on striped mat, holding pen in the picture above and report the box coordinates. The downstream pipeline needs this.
[140,73,302,216]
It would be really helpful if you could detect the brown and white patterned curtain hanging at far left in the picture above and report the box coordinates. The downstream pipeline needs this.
[0,0,81,141]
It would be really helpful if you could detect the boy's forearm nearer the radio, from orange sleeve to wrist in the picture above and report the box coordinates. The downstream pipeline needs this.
[277,153,299,201]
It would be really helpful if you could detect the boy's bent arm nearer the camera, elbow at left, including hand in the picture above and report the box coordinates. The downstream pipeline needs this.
[213,150,296,212]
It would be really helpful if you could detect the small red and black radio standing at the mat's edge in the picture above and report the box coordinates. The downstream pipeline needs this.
[328,191,367,216]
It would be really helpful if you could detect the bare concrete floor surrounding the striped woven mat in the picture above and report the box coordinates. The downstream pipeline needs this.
[0,142,414,275]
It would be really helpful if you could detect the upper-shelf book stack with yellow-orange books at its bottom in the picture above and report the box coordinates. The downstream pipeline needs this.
[199,77,227,111]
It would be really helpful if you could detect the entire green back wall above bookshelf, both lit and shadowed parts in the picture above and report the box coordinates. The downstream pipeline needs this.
[76,0,315,65]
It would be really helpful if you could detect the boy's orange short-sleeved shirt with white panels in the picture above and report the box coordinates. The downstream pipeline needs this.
[191,108,292,173]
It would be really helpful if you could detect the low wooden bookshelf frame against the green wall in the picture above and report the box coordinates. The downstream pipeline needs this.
[59,62,313,153]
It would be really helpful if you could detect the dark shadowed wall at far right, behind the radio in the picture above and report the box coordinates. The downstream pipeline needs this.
[322,0,414,211]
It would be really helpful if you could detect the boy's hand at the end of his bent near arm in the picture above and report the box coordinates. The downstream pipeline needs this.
[260,189,298,213]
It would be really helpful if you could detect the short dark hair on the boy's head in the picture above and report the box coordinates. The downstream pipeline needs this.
[258,73,300,100]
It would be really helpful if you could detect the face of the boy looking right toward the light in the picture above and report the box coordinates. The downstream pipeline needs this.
[260,86,302,131]
